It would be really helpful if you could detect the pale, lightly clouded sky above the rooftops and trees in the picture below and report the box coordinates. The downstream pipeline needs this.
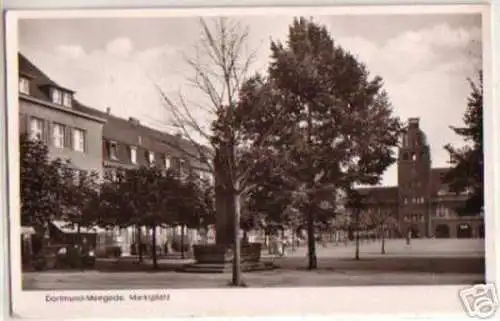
[18,14,482,185]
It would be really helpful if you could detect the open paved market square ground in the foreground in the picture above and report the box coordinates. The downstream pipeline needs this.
[23,240,484,290]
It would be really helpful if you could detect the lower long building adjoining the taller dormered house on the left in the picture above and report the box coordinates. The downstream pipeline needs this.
[95,108,213,256]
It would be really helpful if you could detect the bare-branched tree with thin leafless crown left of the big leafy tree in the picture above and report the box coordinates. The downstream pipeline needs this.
[158,17,288,286]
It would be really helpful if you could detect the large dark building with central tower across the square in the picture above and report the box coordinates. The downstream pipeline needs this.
[350,118,484,238]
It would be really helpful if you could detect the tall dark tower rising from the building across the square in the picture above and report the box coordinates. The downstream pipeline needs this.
[398,118,431,237]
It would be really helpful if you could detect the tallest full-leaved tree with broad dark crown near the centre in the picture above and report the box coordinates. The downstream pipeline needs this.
[240,18,401,269]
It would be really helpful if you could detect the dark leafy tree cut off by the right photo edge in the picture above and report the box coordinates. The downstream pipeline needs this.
[445,72,484,215]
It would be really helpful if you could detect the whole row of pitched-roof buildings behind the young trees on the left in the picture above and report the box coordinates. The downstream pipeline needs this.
[18,54,213,255]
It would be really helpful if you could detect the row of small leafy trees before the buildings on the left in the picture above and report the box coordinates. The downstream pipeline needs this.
[20,135,214,268]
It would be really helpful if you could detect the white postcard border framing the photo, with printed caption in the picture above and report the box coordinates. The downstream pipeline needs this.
[6,5,499,319]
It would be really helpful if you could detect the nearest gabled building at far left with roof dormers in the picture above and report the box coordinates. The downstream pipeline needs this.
[18,54,106,172]
